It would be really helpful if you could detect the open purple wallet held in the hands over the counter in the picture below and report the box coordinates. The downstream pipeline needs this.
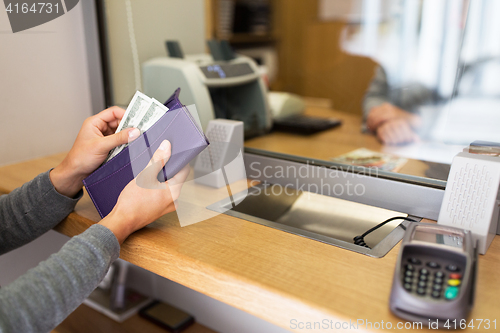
[83,88,209,218]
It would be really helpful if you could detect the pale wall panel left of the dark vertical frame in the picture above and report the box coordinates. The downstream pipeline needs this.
[0,4,92,165]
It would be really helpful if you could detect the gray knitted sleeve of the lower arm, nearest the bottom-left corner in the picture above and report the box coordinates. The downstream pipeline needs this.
[0,224,120,333]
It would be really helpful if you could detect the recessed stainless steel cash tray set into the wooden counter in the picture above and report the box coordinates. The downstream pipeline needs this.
[207,184,421,258]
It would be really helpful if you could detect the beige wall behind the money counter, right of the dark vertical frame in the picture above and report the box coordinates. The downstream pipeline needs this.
[105,0,205,105]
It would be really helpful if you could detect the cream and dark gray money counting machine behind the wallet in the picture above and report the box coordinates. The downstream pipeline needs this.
[143,41,272,138]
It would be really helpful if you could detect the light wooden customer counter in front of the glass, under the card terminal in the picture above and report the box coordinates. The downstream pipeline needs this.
[0,108,500,332]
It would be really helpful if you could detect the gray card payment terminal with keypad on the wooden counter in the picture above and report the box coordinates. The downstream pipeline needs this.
[390,223,477,327]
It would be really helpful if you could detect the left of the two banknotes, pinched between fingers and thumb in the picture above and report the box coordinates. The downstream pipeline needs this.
[104,91,152,163]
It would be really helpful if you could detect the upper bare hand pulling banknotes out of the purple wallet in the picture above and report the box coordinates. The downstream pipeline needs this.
[50,106,140,197]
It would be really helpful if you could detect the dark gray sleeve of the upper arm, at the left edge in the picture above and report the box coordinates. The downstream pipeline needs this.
[0,171,83,254]
